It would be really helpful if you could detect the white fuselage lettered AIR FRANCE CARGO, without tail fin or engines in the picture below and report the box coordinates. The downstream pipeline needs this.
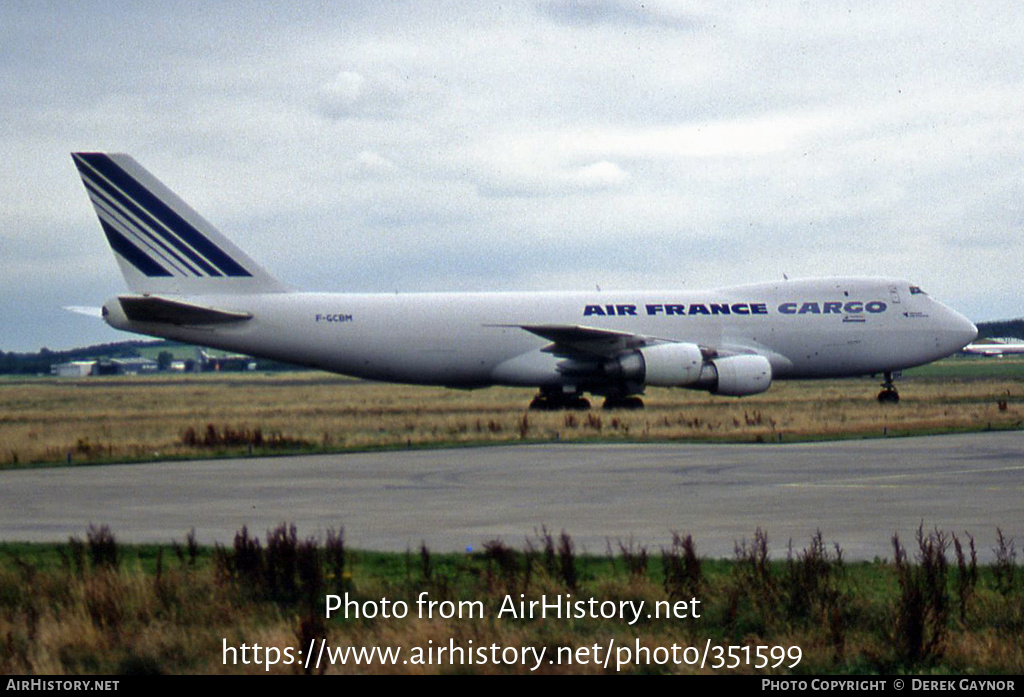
[104,278,977,387]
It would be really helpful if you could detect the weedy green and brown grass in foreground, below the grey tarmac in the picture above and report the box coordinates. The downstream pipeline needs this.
[0,526,1024,676]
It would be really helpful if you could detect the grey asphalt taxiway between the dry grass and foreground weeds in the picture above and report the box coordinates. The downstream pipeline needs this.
[0,432,1024,561]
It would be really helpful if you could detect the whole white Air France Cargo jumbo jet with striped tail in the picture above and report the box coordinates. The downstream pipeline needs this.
[73,153,977,409]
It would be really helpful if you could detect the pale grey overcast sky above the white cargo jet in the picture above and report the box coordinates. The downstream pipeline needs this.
[0,0,1024,351]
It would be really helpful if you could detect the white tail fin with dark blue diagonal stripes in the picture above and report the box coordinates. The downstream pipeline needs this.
[72,153,288,295]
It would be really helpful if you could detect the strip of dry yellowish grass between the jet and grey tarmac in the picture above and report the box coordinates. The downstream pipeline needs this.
[0,366,1024,467]
